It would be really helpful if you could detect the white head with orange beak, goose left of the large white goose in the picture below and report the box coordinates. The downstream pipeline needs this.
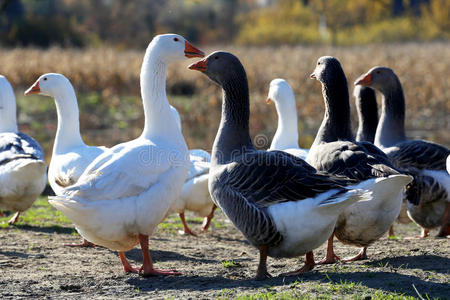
[25,73,73,99]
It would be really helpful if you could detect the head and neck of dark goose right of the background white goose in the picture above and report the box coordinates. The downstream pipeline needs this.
[311,56,353,145]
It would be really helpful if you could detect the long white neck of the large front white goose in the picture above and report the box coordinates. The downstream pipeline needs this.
[140,44,184,141]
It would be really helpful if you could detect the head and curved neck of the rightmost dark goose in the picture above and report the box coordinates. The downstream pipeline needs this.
[355,67,406,147]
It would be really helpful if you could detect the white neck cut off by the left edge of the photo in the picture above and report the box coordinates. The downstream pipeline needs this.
[0,75,18,132]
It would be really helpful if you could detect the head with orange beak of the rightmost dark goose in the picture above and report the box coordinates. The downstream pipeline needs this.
[355,66,398,94]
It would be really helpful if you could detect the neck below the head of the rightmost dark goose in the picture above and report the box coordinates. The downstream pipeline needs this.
[375,78,407,148]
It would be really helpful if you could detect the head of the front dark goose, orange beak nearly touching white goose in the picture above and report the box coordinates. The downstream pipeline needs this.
[188,51,247,88]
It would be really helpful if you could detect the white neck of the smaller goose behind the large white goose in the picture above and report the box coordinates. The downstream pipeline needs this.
[53,87,84,153]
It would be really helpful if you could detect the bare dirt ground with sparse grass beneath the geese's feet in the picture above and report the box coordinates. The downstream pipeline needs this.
[0,212,450,299]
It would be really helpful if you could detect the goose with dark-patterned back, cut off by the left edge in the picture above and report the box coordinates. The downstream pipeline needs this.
[0,75,47,225]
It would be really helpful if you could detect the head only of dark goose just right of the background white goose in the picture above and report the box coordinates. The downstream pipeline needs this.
[310,56,345,85]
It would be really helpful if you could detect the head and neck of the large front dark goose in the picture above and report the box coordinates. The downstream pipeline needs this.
[189,51,254,163]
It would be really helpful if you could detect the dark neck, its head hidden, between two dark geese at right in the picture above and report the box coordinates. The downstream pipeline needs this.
[356,91,378,143]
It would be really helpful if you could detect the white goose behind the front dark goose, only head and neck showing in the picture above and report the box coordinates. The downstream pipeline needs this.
[266,78,308,159]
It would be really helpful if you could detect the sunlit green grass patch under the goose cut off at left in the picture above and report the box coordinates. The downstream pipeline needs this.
[0,197,72,226]
